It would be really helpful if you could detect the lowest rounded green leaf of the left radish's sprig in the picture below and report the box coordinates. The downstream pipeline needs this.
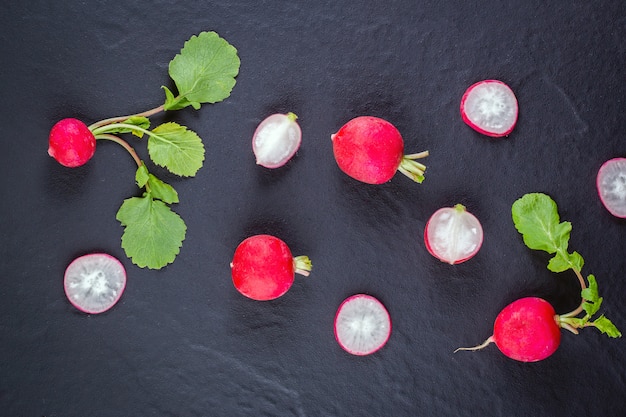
[116,194,187,269]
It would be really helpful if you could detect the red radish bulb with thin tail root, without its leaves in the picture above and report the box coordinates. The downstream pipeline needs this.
[455,297,561,362]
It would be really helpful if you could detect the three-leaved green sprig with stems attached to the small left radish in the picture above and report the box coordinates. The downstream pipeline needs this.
[89,32,240,269]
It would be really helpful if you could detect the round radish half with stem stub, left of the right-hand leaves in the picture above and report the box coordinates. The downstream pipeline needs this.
[424,204,483,265]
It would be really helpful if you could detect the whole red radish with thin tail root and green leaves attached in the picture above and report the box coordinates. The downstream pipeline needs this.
[455,193,622,362]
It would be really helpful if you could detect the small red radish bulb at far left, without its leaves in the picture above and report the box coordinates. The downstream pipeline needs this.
[48,118,96,168]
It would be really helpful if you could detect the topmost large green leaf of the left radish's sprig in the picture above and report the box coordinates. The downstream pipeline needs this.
[163,32,240,110]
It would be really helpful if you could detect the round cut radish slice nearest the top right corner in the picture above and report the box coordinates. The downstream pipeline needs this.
[461,80,518,137]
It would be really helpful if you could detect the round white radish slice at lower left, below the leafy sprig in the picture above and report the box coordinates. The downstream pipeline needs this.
[64,253,126,314]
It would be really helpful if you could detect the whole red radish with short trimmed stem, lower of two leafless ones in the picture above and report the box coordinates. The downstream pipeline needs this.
[230,235,311,301]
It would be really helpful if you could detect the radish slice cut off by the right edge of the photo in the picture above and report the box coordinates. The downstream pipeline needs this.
[596,158,626,218]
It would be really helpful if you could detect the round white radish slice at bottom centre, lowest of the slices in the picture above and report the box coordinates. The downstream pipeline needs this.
[335,294,391,356]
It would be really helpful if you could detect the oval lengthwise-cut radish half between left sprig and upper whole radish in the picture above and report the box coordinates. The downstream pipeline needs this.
[252,113,302,168]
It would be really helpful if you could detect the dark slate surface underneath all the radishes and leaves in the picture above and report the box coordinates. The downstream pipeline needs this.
[0,0,626,417]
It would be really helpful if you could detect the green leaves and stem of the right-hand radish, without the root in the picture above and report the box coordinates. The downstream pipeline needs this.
[511,193,622,338]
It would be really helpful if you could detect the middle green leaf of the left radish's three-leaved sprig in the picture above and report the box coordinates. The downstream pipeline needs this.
[148,122,204,177]
